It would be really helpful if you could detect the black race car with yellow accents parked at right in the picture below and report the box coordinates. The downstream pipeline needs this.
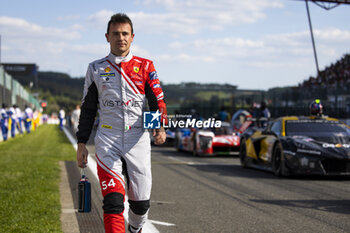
[240,116,350,176]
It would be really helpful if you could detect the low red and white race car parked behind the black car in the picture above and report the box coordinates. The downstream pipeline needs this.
[175,122,240,155]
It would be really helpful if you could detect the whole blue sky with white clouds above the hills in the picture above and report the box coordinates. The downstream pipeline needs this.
[0,0,350,90]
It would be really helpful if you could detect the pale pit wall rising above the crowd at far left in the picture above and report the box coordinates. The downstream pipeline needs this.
[0,65,40,109]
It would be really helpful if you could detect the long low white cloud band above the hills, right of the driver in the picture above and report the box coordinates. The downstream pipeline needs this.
[158,28,350,69]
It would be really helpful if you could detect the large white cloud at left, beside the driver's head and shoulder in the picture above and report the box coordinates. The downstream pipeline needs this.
[0,16,109,76]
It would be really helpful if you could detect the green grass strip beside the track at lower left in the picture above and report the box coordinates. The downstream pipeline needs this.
[0,125,75,233]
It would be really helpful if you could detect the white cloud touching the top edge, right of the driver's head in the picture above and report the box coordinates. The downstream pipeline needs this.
[136,0,283,33]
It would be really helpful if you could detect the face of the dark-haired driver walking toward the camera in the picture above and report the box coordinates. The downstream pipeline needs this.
[106,23,134,57]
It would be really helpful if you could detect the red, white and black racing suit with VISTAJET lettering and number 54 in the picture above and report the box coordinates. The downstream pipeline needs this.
[77,52,166,233]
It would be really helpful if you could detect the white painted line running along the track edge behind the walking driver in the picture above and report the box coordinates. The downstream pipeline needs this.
[63,127,175,233]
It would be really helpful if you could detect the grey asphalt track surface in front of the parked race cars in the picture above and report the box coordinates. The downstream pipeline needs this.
[65,127,350,233]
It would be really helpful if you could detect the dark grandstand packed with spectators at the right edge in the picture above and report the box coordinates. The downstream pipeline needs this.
[265,54,350,118]
